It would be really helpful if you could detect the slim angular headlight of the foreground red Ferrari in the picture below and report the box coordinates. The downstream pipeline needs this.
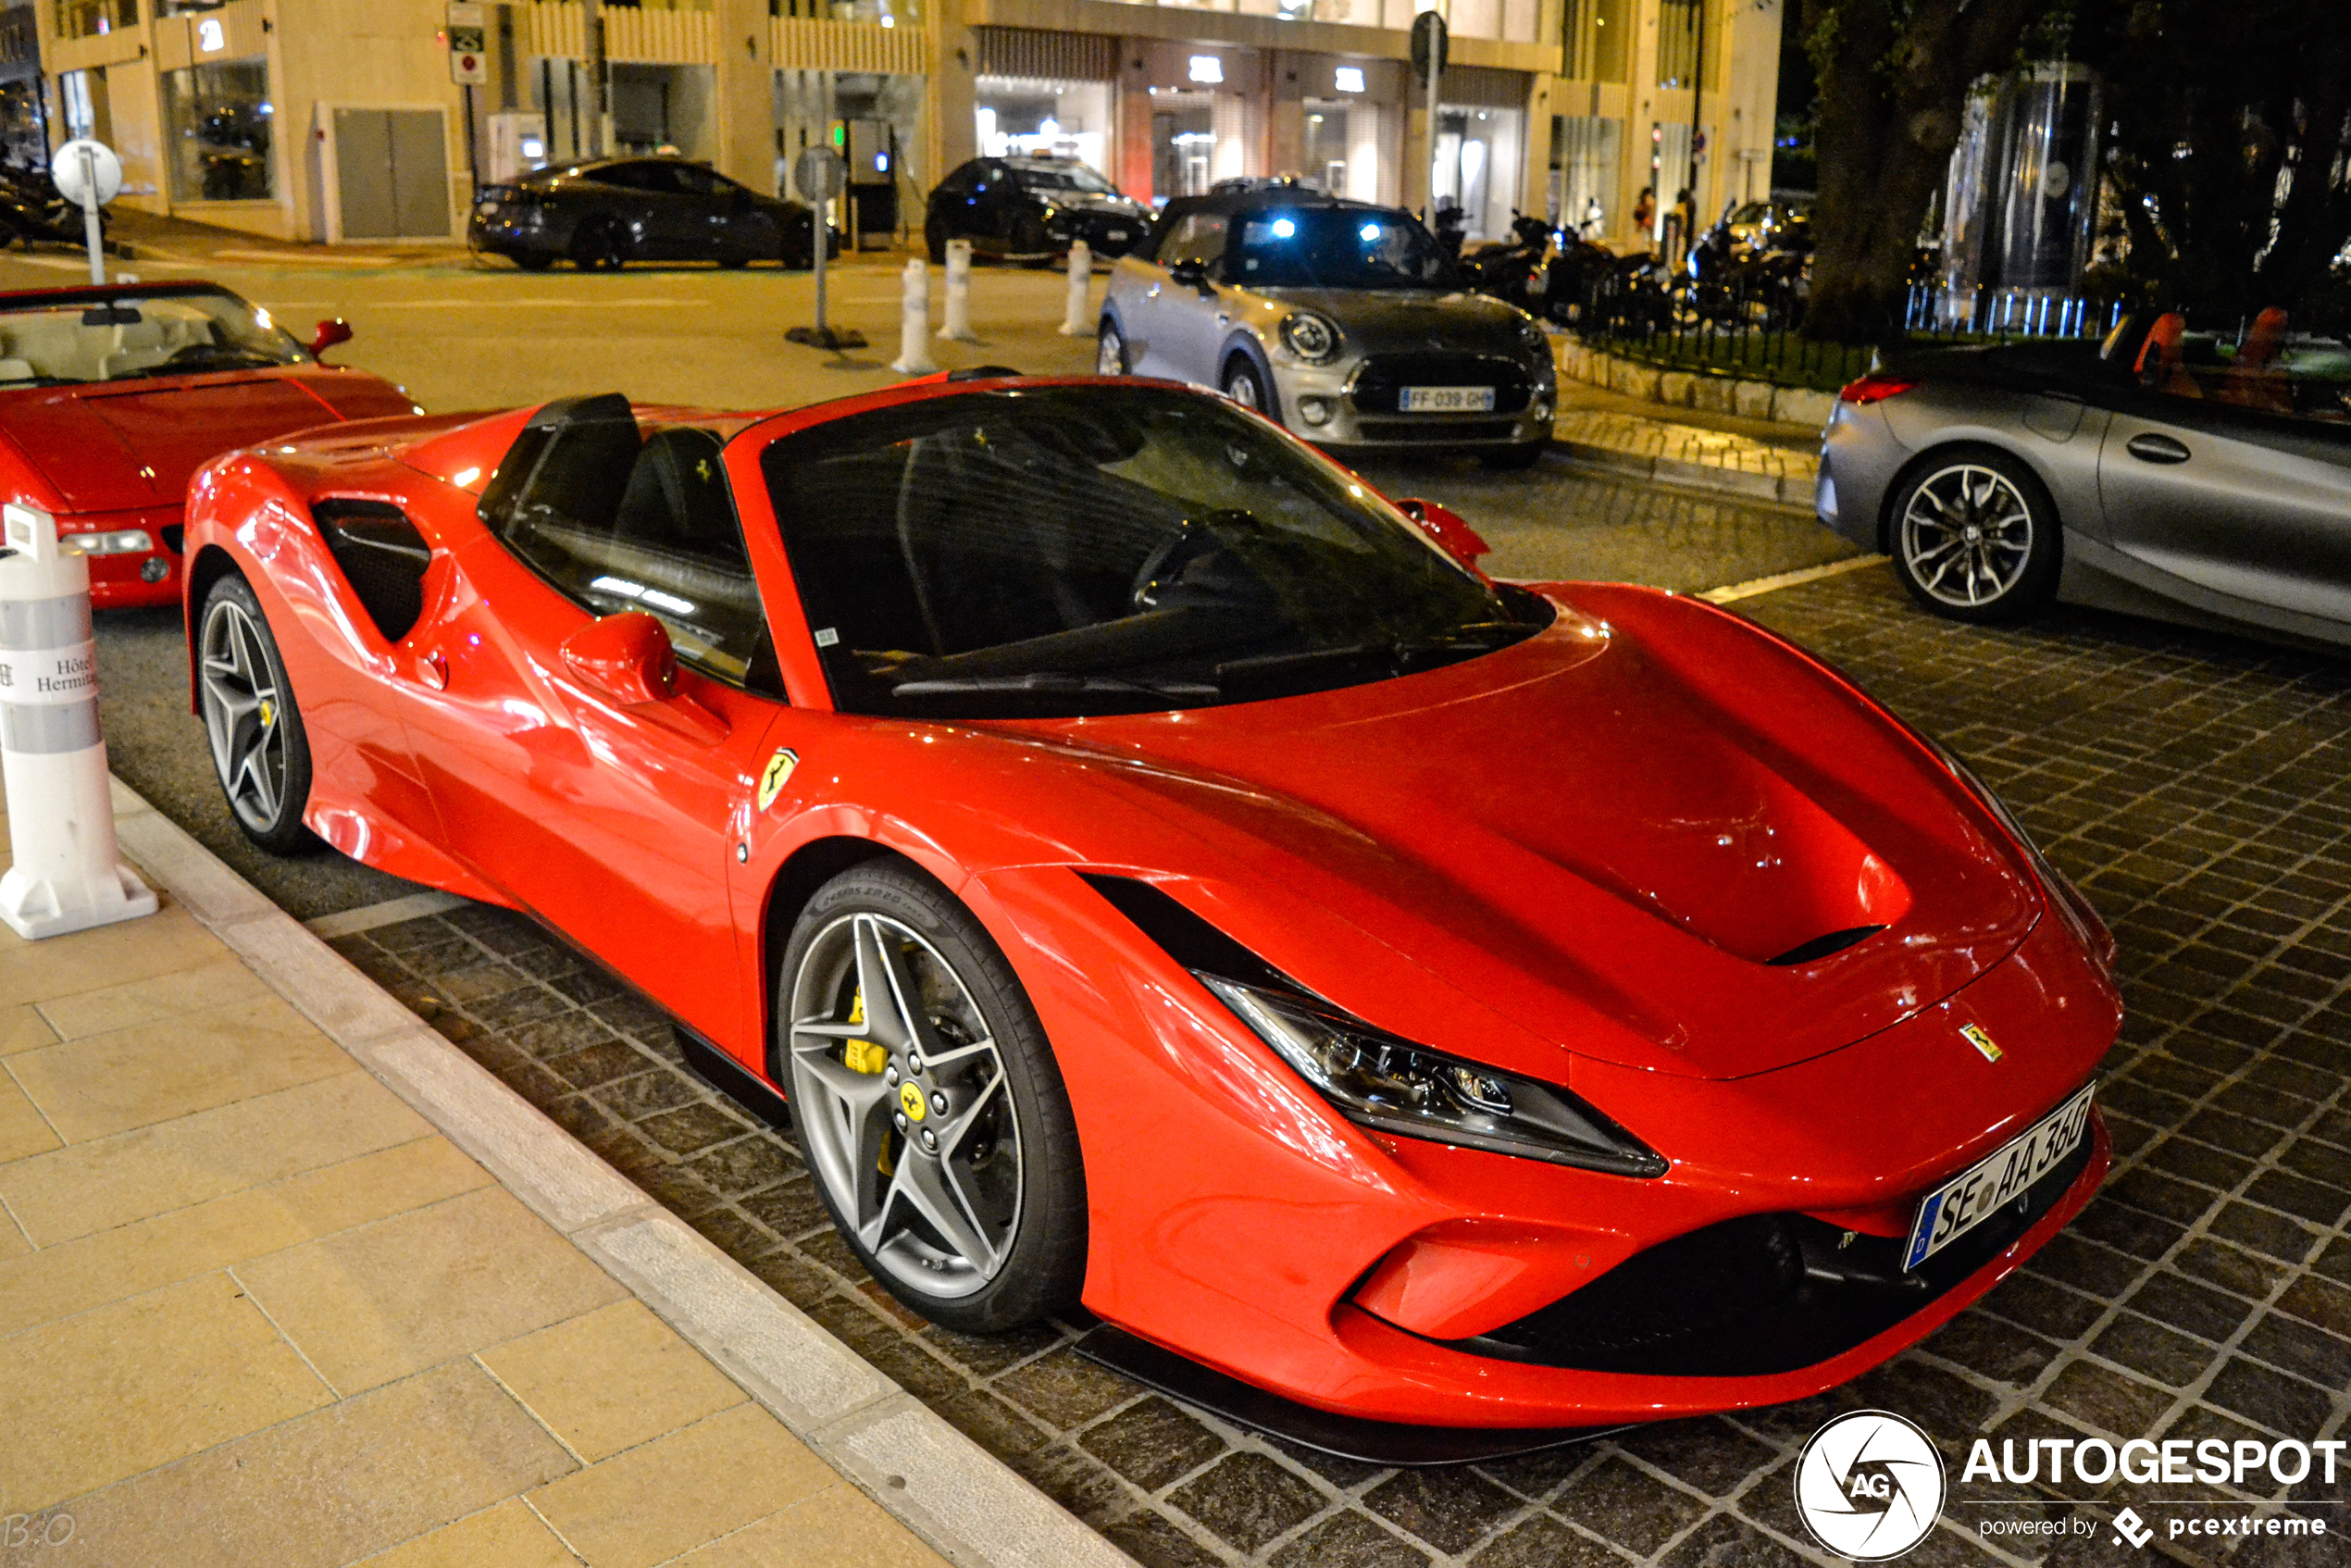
[1192,971,1667,1176]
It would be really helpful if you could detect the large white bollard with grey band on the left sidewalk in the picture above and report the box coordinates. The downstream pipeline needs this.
[0,505,155,936]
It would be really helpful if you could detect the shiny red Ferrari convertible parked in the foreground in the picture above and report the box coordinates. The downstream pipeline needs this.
[188,374,2121,1458]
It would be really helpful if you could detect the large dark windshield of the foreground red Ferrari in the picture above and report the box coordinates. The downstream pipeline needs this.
[762,386,1549,717]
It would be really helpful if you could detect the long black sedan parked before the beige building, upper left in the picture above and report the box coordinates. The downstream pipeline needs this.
[466,157,841,273]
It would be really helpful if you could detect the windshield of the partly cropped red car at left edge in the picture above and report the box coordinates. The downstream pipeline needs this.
[0,292,310,388]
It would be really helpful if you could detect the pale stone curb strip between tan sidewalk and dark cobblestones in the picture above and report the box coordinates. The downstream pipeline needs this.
[113,778,1136,1568]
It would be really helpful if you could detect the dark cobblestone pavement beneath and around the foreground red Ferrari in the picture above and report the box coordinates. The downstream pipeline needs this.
[317,571,2351,1568]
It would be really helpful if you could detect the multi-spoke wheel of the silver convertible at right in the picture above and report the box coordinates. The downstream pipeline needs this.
[1885,447,2064,626]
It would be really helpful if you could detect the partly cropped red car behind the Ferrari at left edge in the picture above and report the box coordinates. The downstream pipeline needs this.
[0,282,423,609]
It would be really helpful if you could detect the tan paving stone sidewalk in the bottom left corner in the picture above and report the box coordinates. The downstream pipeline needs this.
[0,823,945,1568]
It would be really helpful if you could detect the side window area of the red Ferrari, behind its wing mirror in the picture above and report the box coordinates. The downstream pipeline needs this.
[482,408,774,687]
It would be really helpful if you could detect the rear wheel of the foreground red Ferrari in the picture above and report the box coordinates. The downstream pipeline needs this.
[195,571,317,855]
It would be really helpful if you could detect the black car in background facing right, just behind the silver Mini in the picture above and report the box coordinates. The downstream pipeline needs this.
[922,157,1152,261]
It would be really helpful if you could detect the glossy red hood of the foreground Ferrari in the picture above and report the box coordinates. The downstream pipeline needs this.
[982,590,2041,1079]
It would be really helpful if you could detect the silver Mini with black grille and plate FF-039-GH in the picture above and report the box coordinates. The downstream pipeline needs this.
[1096,186,1556,467]
